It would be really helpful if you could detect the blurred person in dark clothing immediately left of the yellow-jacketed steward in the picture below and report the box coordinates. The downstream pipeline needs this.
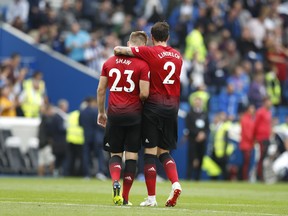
[52,99,69,177]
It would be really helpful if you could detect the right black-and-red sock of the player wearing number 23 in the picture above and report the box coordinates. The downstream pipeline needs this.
[122,160,136,201]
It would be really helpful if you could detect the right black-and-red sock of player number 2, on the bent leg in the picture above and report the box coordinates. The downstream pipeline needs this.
[159,152,179,184]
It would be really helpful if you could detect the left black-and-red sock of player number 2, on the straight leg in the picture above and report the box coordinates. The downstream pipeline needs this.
[144,154,157,196]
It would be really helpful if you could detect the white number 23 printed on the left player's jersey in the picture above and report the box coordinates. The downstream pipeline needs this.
[109,68,135,92]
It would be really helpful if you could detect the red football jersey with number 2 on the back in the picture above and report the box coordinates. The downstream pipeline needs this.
[132,46,183,116]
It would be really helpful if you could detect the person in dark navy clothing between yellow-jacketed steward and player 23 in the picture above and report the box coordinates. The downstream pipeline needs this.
[79,97,107,180]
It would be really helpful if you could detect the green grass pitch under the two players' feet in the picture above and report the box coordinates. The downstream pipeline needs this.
[0,177,288,216]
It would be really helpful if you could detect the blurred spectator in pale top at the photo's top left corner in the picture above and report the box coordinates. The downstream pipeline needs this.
[6,0,29,30]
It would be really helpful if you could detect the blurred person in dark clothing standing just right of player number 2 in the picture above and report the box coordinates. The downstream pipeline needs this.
[185,97,209,181]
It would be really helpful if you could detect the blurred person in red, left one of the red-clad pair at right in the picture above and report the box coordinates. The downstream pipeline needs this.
[239,104,255,181]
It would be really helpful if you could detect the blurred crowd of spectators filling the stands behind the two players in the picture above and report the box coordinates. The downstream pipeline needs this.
[0,0,288,182]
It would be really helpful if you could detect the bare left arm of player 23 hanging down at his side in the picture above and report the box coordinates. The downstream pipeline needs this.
[97,76,108,127]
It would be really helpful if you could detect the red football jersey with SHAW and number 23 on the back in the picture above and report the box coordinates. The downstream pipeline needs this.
[101,56,149,116]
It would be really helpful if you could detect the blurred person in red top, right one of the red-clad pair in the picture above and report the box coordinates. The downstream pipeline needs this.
[254,97,272,181]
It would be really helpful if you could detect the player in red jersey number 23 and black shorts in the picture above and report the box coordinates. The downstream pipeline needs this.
[97,31,150,205]
